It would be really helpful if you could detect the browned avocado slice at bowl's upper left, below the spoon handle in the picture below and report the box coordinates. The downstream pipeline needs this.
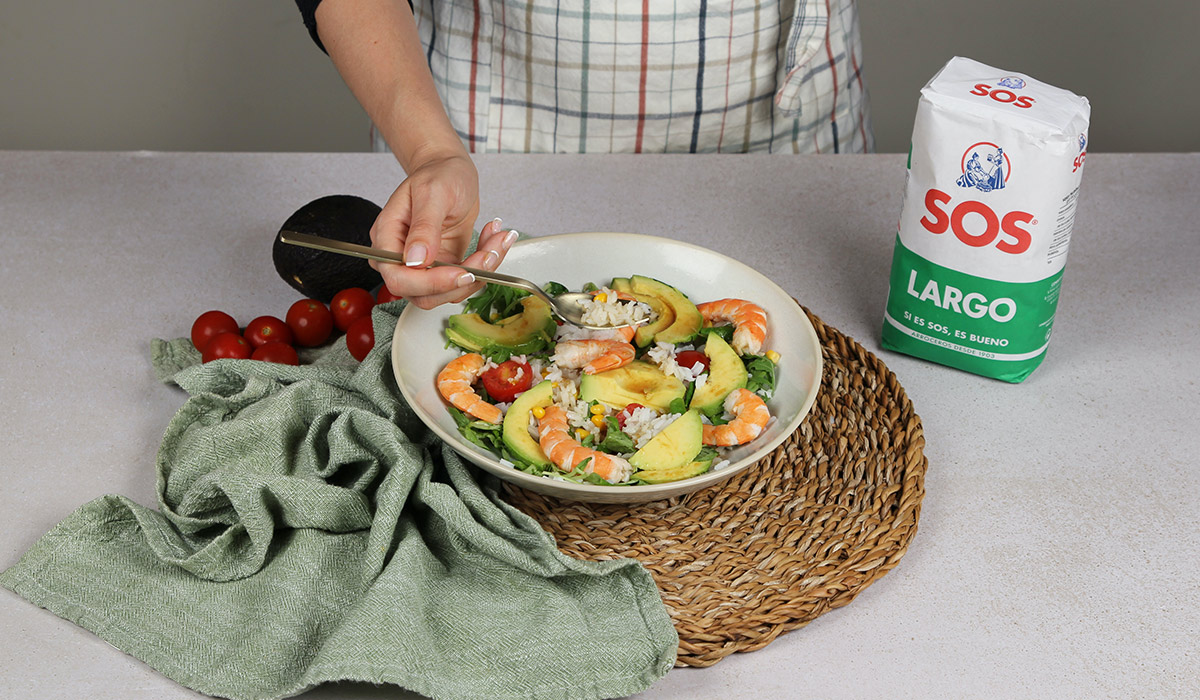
[446,297,558,357]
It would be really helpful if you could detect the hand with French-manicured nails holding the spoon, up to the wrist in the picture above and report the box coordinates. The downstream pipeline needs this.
[371,152,517,309]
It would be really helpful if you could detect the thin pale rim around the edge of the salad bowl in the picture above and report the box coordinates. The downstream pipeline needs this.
[391,232,824,501]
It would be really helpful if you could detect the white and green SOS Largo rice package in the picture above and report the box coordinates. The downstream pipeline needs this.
[882,58,1091,382]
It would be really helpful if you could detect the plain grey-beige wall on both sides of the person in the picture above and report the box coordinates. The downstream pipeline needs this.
[0,0,1200,152]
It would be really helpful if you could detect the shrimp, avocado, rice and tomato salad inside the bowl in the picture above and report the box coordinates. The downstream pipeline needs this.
[436,274,780,486]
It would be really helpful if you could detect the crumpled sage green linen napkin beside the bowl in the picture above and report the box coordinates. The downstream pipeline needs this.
[0,301,678,700]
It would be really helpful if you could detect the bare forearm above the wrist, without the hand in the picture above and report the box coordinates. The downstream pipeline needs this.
[317,0,466,172]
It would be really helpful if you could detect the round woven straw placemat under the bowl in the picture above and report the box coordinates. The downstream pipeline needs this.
[503,309,926,666]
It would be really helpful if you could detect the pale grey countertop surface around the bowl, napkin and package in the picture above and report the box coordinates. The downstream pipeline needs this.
[0,152,1200,700]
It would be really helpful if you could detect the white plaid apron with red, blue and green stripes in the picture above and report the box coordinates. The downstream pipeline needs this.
[364,0,874,152]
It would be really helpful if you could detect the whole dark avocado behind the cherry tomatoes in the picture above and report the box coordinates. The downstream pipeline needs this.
[271,195,383,304]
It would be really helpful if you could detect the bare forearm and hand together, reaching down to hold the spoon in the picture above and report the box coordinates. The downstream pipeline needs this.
[316,0,516,309]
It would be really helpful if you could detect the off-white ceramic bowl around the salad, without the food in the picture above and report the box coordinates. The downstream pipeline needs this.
[391,233,821,503]
